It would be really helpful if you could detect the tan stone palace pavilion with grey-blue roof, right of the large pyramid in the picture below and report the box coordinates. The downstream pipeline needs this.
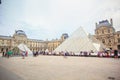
[94,19,120,50]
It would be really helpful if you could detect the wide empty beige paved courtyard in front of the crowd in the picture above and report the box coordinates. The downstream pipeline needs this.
[0,56,120,80]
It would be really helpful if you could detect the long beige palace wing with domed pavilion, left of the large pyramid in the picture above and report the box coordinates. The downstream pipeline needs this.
[0,30,66,52]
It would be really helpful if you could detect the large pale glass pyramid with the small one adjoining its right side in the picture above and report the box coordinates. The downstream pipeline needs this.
[54,27,105,53]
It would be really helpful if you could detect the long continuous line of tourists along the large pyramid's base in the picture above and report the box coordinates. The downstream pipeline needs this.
[33,50,120,58]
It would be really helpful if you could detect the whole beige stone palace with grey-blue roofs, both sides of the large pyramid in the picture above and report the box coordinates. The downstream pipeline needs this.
[0,19,120,52]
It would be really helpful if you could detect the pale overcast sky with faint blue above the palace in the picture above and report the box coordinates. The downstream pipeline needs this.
[0,0,120,40]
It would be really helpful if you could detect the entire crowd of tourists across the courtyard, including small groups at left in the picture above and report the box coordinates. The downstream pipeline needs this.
[2,50,120,59]
